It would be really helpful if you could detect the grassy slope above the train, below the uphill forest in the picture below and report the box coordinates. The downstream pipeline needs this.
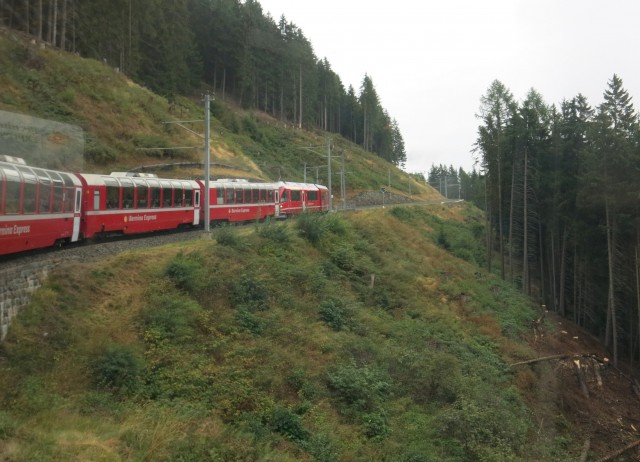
[0,30,439,199]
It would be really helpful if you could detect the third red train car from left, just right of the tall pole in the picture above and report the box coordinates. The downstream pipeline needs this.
[201,179,279,224]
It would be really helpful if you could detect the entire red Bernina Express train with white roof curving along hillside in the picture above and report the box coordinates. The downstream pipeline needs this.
[0,156,329,255]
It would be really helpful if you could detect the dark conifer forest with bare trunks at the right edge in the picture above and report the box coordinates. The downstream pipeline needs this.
[462,74,640,364]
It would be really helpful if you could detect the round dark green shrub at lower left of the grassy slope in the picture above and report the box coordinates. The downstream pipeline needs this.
[91,344,144,394]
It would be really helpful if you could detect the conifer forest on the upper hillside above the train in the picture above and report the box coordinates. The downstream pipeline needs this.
[0,0,406,166]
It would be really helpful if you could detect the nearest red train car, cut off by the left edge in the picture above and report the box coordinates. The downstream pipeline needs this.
[0,156,82,255]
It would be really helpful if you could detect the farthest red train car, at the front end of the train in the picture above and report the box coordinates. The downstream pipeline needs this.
[277,181,329,217]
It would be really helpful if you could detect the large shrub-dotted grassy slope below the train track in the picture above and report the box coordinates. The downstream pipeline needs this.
[0,206,575,461]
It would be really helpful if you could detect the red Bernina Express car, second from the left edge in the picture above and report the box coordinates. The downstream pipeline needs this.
[76,172,202,239]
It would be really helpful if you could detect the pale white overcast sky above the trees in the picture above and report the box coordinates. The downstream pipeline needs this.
[259,0,640,172]
